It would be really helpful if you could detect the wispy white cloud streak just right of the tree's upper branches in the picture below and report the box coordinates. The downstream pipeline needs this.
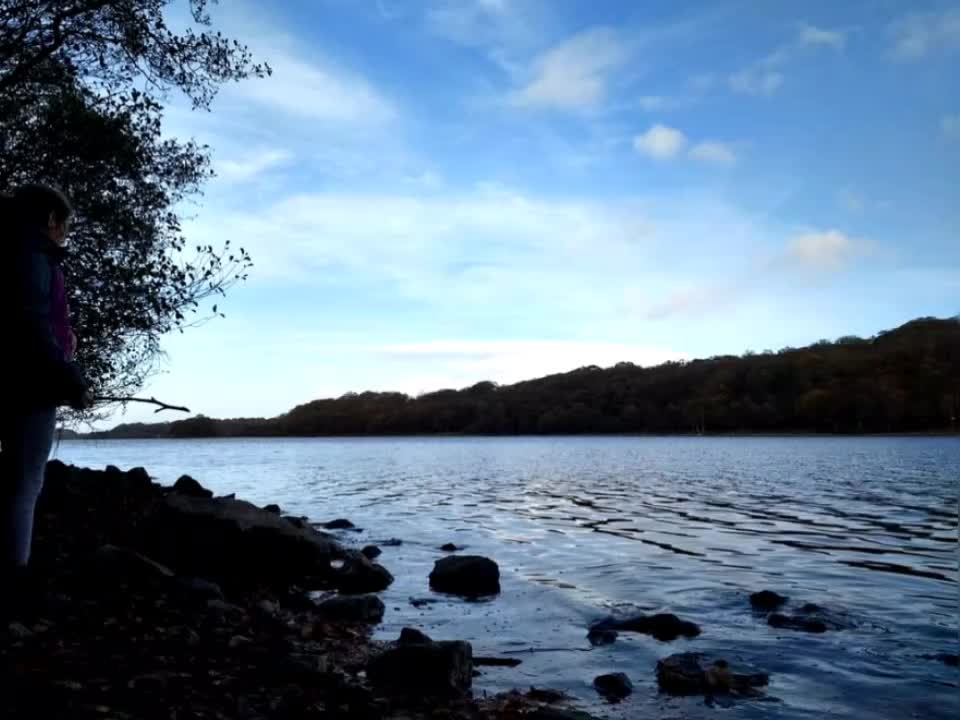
[231,48,398,127]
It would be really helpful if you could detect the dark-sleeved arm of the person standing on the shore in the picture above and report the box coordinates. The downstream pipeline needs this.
[13,249,88,405]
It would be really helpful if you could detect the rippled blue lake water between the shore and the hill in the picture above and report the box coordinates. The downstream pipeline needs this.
[56,438,960,718]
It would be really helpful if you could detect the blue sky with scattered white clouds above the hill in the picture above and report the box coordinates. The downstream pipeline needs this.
[107,0,960,422]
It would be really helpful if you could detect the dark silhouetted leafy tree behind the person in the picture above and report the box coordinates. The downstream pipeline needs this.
[0,0,270,408]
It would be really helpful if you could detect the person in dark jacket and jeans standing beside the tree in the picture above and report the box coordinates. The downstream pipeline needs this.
[0,185,92,604]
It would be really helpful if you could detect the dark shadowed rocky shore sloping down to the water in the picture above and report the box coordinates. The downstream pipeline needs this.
[0,461,589,720]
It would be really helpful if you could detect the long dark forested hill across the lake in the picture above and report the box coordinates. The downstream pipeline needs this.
[89,318,960,438]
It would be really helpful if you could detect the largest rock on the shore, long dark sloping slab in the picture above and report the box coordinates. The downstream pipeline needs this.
[138,493,344,588]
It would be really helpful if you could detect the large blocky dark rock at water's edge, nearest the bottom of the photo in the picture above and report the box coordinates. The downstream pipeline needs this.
[367,641,473,697]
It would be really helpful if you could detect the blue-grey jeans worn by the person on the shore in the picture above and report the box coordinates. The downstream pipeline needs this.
[0,408,57,570]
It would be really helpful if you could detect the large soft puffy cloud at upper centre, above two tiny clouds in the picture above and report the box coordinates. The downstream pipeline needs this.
[509,28,627,111]
